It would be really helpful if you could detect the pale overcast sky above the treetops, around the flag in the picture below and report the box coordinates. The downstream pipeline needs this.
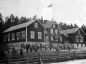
[0,0,86,26]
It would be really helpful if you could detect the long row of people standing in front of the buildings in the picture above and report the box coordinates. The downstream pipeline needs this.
[7,44,73,55]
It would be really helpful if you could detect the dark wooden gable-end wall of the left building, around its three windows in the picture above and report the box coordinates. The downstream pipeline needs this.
[27,21,44,42]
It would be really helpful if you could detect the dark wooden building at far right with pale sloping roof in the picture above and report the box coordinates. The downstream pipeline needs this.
[61,28,86,48]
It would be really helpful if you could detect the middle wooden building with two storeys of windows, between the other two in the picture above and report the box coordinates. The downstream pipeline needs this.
[41,20,58,43]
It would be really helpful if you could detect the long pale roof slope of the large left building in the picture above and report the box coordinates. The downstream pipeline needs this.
[3,20,36,33]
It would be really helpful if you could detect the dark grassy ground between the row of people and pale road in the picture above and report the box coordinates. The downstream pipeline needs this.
[10,50,86,64]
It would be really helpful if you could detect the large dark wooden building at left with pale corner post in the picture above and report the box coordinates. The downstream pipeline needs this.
[3,20,44,46]
